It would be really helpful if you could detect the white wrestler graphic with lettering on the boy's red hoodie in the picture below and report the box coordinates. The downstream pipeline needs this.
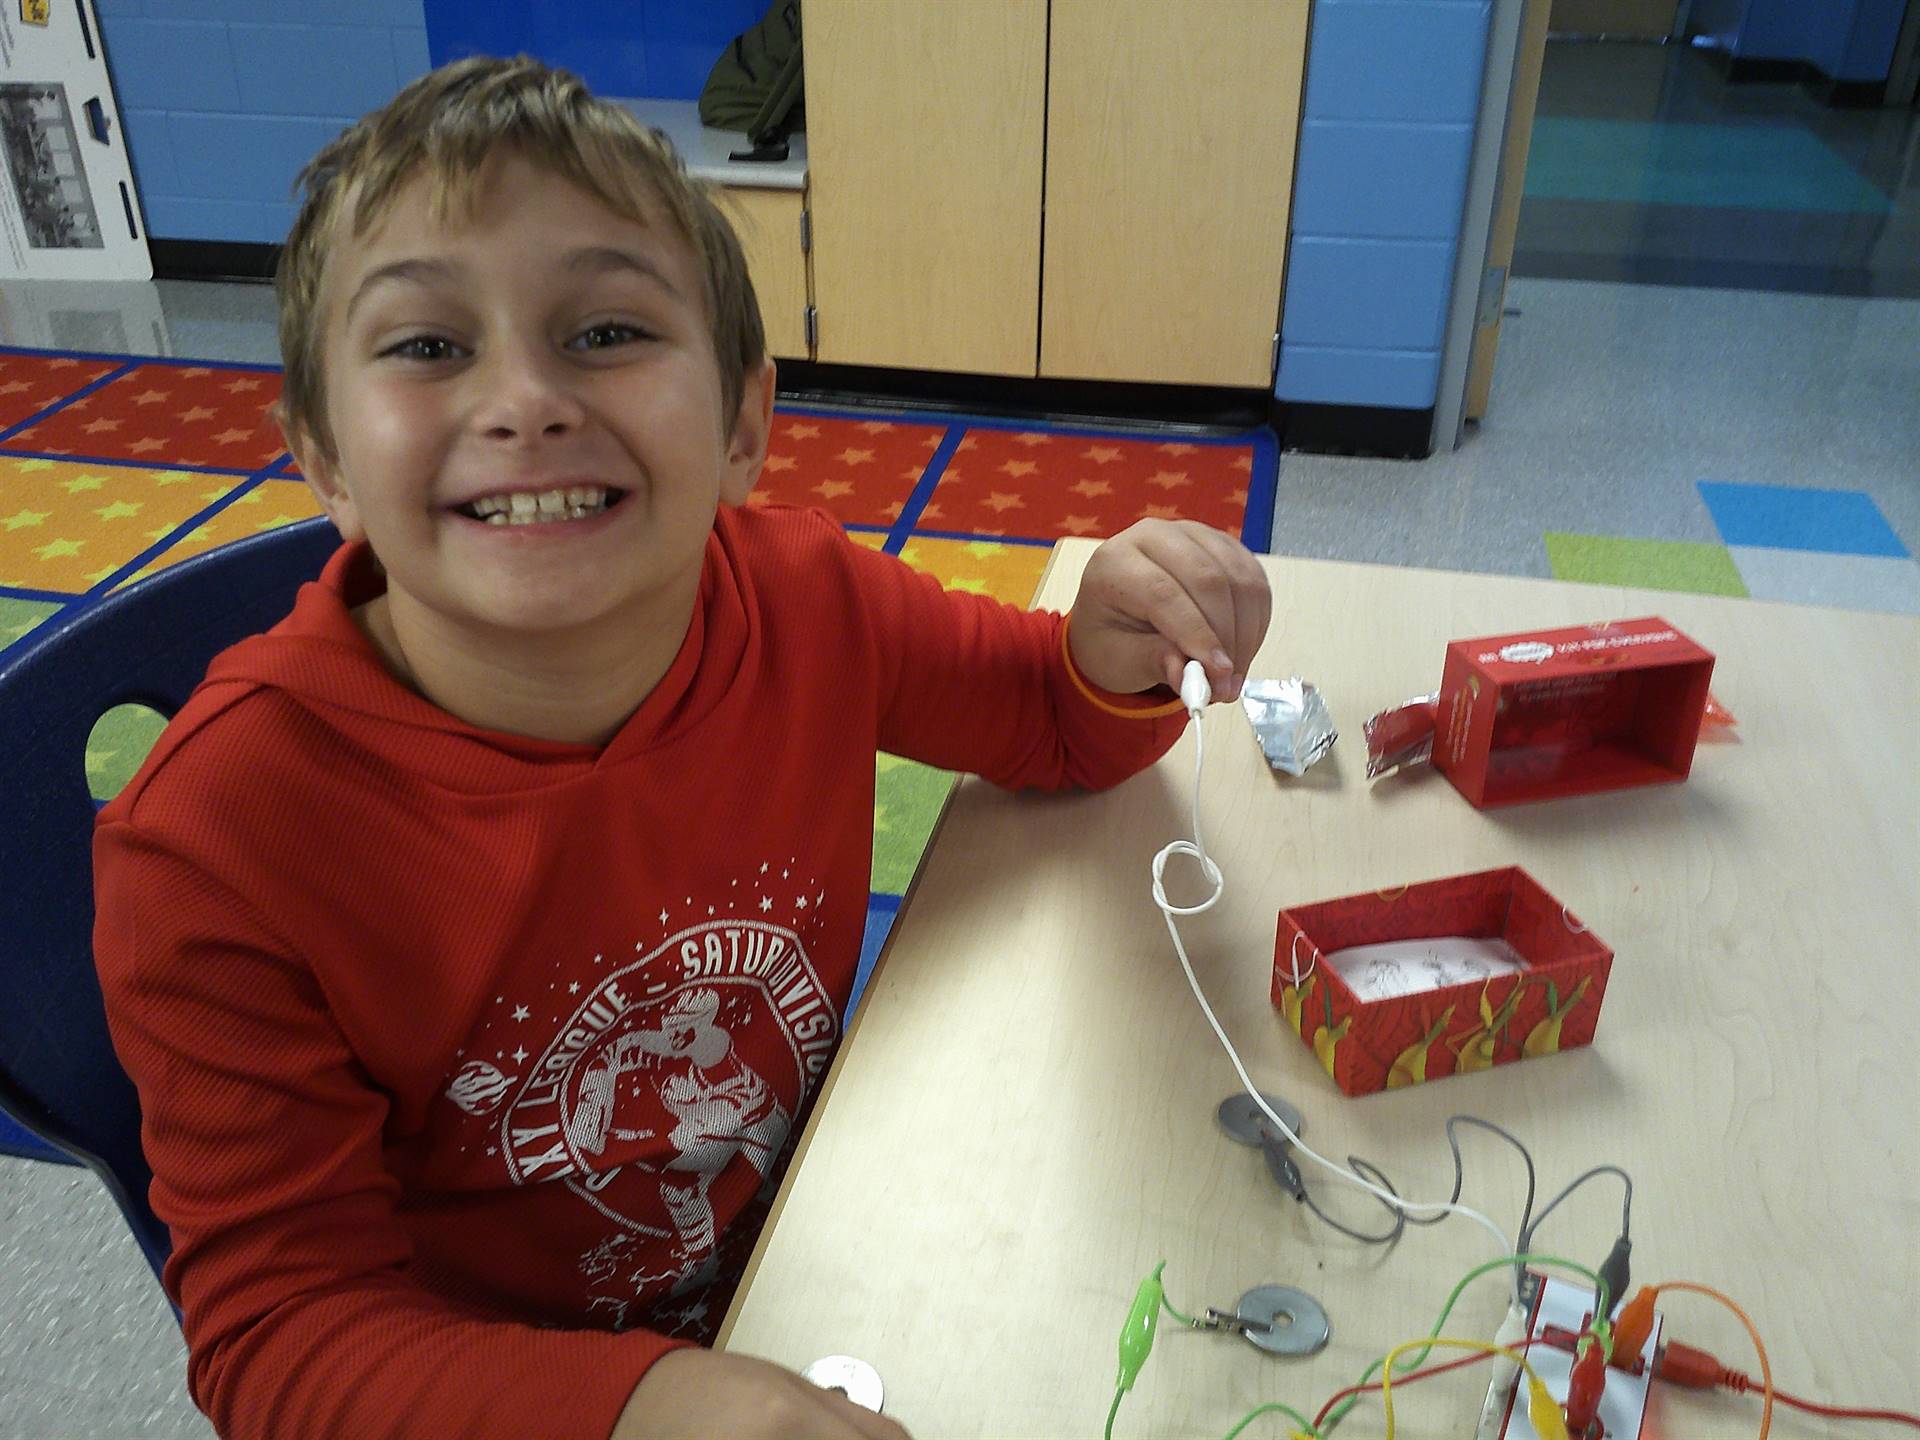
[445,870,839,1329]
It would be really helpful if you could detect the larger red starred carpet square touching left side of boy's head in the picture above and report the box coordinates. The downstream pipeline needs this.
[8,365,284,470]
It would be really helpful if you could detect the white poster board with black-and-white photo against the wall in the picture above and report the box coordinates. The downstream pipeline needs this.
[0,0,154,280]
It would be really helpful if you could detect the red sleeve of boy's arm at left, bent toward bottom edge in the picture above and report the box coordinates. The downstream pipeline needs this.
[94,822,672,1440]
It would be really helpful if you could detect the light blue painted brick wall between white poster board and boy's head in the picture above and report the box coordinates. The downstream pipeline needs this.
[96,0,430,242]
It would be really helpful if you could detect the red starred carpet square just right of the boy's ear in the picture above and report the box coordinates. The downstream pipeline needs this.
[749,415,947,524]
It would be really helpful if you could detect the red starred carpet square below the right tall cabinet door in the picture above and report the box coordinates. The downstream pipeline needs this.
[916,430,1254,540]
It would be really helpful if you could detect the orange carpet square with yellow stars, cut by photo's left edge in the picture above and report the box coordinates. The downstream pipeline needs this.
[0,455,246,595]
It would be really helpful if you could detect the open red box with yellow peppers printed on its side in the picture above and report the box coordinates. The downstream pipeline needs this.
[1273,866,1613,1094]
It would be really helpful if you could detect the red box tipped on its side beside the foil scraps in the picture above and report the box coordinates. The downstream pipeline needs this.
[1434,618,1713,808]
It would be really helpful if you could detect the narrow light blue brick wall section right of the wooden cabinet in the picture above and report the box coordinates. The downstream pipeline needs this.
[1275,0,1492,409]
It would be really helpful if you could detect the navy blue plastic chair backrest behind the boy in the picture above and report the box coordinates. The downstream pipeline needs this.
[0,518,340,1275]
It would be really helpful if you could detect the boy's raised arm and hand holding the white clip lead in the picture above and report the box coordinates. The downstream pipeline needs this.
[852,520,1269,789]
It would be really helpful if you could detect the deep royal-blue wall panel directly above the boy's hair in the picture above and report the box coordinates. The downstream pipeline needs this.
[426,0,766,100]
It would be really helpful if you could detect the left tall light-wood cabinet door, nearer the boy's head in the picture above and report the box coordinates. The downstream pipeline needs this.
[804,0,1046,374]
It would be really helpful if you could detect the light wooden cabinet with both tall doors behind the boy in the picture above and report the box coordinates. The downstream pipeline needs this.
[806,0,1308,386]
